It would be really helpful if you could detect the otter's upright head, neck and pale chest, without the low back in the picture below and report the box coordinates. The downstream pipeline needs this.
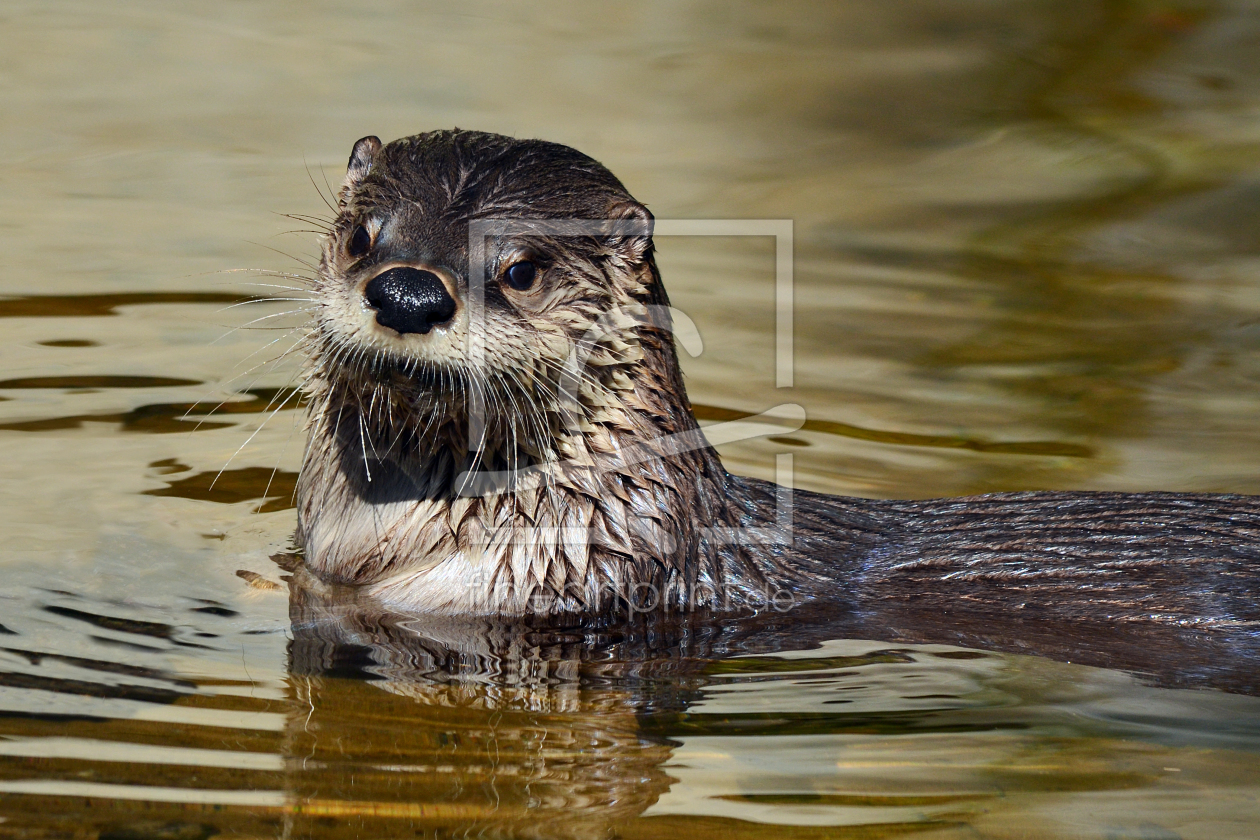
[297,130,781,615]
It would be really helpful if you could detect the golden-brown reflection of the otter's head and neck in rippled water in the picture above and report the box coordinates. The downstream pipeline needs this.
[289,594,672,837]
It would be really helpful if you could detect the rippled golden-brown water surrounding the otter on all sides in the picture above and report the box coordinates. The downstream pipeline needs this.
[0,0,1260,840]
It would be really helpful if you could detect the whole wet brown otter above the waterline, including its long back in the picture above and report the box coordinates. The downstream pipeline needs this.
[297,131,1260,633]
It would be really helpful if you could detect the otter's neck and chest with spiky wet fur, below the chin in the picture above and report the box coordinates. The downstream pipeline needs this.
[297,312,762,615]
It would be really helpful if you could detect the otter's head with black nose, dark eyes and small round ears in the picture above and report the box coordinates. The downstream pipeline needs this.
[312,131,653,413]
